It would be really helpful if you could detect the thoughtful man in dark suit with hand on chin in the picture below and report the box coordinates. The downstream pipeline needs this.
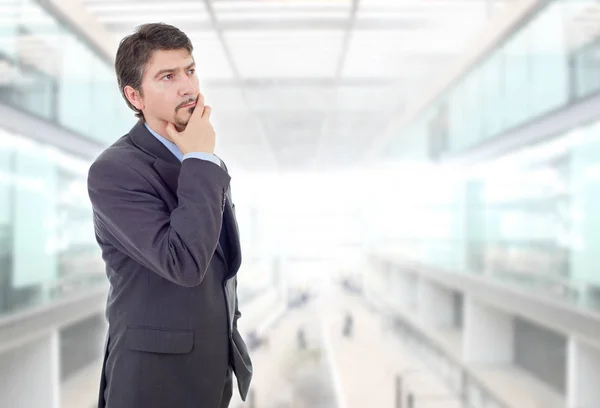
[88,24,252,408]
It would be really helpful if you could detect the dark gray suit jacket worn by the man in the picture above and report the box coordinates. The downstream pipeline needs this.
[88,121,252,408]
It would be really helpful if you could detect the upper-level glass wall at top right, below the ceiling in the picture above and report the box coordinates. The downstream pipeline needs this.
[387,0,600,159]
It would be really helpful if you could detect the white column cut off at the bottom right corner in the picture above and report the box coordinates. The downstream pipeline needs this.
[567,337,600,408]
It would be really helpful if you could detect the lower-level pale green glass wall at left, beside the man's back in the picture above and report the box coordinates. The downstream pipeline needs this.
[0,129,106,314]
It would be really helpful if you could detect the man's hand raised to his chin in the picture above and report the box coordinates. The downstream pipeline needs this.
[166,97,215,154]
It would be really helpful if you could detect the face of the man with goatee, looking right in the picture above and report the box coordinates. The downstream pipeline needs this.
[141,50,203,131]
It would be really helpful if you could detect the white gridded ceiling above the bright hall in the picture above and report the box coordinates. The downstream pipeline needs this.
[81,0,511,171]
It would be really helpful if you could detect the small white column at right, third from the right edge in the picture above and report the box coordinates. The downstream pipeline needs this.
[417,278,454,329]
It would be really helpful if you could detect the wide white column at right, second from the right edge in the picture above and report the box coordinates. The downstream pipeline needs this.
[463,296,514,364]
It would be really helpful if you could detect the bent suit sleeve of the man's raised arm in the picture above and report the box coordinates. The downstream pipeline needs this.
[88,159,230,287]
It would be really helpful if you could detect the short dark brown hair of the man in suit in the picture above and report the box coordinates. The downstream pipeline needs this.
[115,23,194,118]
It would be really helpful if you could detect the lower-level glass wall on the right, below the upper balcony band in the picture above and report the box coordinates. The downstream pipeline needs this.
[380,118,600,309]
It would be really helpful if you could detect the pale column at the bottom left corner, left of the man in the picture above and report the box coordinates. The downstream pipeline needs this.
[0,331,60,408]
